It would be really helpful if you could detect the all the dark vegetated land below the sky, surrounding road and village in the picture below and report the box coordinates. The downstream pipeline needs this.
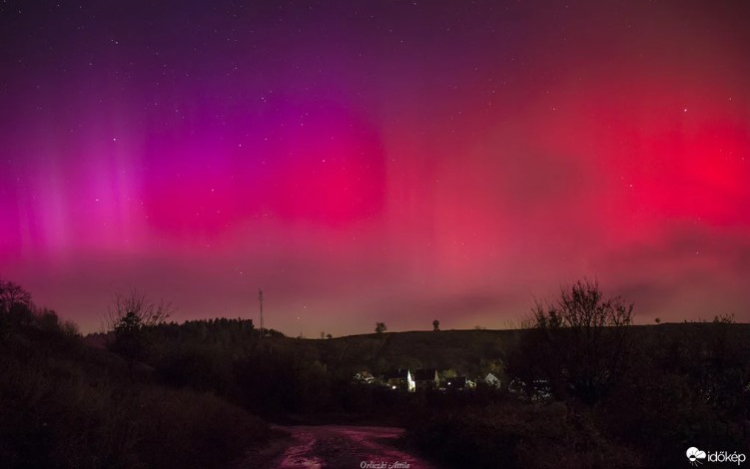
[0,281,750,469]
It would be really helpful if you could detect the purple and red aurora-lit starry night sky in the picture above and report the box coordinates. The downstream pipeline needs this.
[0,0,750,337]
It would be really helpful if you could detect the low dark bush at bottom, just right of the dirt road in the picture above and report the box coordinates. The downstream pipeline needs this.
[405,402,643,469]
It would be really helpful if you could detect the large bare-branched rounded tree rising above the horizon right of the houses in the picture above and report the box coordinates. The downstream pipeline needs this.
[511,280,633,404]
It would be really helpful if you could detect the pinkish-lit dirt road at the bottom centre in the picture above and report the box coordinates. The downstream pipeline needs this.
[241,425,435,469]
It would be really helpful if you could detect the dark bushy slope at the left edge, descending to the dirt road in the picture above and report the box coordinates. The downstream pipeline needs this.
[0,279,269,468]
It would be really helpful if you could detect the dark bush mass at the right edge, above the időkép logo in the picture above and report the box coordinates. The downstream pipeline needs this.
[597,320,750,468]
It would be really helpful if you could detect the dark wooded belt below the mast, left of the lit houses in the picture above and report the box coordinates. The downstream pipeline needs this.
[143,319,434,423]
